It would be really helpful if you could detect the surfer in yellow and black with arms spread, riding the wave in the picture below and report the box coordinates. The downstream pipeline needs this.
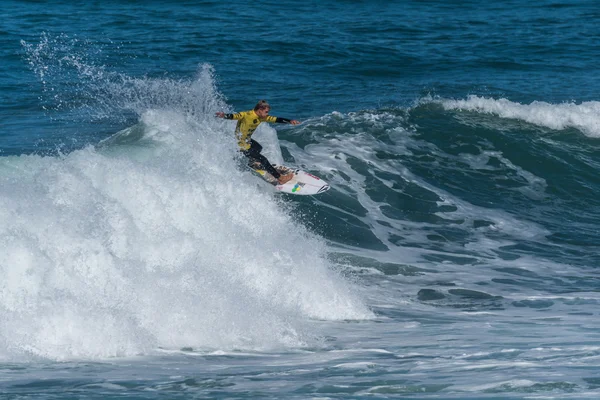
[216,100,300,185]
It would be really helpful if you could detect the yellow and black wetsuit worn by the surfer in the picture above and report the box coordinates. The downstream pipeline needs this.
[224,110,291,179]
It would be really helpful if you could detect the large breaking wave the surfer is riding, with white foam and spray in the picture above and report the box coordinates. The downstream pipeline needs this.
[11,34,597,359]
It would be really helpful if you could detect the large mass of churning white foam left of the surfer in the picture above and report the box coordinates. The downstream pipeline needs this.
[0,70,372,360]
